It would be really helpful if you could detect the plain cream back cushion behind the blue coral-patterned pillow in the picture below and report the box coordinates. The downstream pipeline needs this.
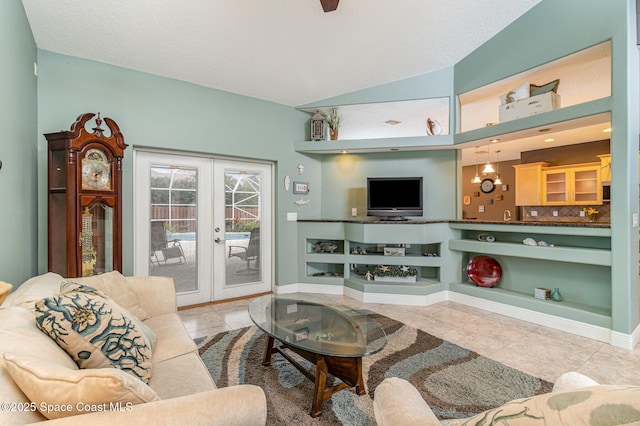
[71,271,149,321]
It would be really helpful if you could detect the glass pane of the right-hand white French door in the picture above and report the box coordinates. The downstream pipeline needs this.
[224,170,262,286]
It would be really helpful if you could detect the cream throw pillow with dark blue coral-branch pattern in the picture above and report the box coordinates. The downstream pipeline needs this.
[36,292,152,383]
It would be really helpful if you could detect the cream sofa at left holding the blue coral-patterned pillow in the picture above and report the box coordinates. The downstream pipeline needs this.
[0,272,266,426]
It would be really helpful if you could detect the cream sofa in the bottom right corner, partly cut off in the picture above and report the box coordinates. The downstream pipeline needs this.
[373,372,640,426]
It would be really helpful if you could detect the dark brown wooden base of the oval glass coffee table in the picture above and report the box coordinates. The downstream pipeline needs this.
[262,336,366,417]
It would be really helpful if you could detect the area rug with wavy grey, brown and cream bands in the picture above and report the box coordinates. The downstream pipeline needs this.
[196,311,553,426]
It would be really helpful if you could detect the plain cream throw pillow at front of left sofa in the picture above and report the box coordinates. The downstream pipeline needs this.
[4,353,160,419]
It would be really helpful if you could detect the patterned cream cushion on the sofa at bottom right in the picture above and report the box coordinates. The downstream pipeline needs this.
[442,385,640,426]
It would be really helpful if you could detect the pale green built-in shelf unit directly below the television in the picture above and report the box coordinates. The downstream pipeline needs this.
[298,221,448,295]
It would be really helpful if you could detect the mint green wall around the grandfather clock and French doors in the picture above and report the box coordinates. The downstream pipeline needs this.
[38,50,310,284]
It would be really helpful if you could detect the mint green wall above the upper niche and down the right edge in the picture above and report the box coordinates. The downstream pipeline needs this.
[454,0,639,333]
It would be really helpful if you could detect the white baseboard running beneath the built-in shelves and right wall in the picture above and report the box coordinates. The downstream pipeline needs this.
[276,283,640,350]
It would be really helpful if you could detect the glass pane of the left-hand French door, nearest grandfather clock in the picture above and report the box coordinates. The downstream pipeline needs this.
[149,166,198,293]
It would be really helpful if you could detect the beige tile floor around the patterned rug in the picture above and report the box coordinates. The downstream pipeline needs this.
[180,295,640,384]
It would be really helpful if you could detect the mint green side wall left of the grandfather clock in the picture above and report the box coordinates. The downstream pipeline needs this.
[0,0,39,285]
